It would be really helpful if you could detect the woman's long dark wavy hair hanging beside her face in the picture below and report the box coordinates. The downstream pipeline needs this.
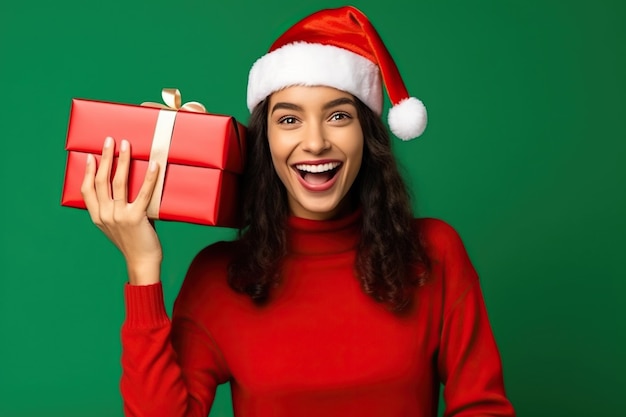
[228,94,430,312]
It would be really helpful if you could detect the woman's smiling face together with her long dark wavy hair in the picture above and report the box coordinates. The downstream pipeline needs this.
[229,86,429,310]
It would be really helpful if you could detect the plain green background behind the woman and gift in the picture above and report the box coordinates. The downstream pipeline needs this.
[0,0,626,417]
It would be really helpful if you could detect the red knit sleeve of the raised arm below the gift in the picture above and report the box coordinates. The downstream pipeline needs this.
[120,272,228,417]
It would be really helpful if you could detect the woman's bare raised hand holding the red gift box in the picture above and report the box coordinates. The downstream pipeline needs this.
[81,137,163,285]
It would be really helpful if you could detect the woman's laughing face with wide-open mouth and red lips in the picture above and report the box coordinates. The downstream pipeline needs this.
[267,86,363,220]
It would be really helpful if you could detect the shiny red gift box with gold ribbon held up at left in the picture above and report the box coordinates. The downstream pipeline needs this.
[61,90,245,227]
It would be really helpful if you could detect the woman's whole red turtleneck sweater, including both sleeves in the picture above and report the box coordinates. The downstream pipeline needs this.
[121,213,514,417]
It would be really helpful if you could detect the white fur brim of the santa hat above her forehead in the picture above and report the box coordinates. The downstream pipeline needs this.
[247,42,383,115]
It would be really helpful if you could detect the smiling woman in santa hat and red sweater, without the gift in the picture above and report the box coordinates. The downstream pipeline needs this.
[83,7,514,417]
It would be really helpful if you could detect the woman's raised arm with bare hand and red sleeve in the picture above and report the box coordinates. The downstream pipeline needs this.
[81,138,225,417]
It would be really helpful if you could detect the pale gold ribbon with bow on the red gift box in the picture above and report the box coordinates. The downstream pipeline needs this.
[141,88,206,219]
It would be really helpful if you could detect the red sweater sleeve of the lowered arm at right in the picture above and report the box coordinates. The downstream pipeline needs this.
[428,219,515,417]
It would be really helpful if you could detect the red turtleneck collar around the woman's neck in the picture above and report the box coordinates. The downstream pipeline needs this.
[287,209,362,255]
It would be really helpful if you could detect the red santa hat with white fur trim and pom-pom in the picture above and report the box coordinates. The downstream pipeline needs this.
[248,6,426,140]
